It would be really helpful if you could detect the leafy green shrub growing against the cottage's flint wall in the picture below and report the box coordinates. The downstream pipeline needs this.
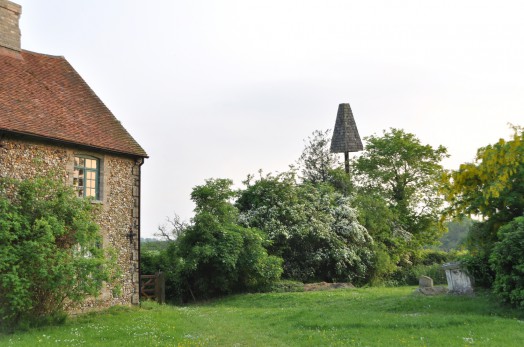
[0,178,117,327]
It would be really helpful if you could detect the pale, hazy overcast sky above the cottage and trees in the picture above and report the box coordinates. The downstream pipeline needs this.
[14,0,524,237]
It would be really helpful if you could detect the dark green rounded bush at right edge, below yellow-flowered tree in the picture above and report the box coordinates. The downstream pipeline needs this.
[490,217,524,308]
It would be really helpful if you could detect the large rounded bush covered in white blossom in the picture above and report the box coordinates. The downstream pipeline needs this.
[237,172,373,284]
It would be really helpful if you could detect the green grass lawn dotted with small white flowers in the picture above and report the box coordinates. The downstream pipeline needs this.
[0,287,524,346]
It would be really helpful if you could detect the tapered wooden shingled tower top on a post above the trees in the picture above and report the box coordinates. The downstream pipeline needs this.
[331,104,364,174]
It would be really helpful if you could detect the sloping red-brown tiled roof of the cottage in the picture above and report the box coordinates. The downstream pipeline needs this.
[0,51,147,157]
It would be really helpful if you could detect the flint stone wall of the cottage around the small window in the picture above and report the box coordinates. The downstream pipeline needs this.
[0,135,140,312]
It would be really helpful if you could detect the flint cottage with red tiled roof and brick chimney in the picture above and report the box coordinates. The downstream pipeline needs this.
[0,0,147,309]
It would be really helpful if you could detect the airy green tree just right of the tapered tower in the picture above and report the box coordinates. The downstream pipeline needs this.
[353,129,447,249]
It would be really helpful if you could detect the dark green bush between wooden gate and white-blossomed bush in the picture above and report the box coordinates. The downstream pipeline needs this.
[166,179,282,301]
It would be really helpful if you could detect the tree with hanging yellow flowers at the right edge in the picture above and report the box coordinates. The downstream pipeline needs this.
[443,126,524,290]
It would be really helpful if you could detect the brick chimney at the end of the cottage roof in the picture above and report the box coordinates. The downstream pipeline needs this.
[0,0,22,56]
